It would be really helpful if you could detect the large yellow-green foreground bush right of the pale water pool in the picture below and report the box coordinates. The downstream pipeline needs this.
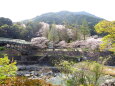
[60,61,103,86]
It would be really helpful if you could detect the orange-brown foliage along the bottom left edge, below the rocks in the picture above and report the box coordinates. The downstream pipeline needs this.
[0,77,54,86]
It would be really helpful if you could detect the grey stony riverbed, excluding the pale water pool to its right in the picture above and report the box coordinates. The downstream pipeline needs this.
[17,64,59,78]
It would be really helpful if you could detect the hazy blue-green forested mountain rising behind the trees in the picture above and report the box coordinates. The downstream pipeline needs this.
[25,11,103,25]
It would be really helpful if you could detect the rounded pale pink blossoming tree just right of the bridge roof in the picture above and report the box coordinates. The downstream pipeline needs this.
[31,37,49,48]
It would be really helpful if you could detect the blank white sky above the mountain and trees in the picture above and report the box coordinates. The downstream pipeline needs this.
[0,0,115,22]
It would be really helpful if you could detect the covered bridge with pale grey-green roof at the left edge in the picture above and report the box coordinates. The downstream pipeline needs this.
[0,37,31,54]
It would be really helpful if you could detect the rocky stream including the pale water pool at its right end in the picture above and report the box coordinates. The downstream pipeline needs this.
[17,64,66,86]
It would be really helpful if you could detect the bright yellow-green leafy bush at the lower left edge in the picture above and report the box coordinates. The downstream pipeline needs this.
[0,55,17,83]
